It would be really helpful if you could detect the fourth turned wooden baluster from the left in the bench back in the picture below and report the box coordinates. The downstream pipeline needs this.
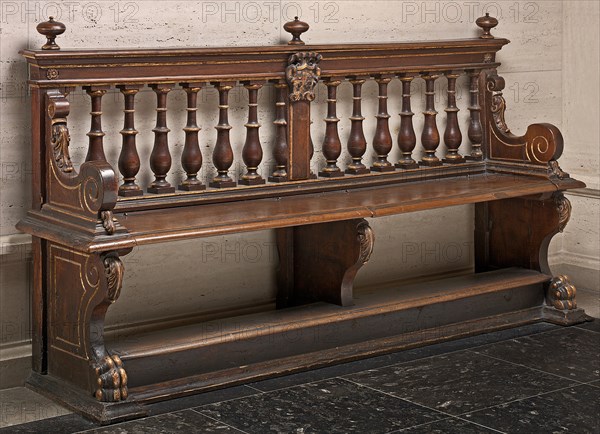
[179,83,206,191]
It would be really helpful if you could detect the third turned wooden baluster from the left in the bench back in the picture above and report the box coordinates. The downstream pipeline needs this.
[148,84,175,193]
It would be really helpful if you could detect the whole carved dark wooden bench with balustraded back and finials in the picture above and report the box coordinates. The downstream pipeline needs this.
[18,16,587,423]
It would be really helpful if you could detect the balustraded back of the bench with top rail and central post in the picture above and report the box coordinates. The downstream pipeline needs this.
[23,13,508,207]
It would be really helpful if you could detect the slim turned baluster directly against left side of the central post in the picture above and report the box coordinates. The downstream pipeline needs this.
[269,80,289,182]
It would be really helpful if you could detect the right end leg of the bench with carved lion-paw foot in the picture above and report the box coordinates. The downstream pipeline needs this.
[475,192,587,324]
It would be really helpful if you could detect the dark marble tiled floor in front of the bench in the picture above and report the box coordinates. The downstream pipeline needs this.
[0,320,600,434]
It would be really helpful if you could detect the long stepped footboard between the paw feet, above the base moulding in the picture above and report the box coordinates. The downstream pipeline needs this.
[106,268,550,399]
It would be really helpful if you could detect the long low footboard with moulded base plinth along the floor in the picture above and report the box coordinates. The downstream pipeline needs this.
[29,268,588,423]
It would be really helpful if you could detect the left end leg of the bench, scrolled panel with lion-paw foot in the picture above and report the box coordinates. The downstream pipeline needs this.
[45,242,128,402]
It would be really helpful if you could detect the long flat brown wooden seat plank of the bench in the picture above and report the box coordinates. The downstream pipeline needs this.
[116,174,557,245]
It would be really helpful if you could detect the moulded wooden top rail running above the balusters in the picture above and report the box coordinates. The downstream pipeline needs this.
[20,14,509,87]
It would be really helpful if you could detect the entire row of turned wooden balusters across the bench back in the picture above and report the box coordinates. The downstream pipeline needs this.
[78,70,482,197]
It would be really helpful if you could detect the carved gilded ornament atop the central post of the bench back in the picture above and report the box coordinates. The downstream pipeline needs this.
[285,51,323,101]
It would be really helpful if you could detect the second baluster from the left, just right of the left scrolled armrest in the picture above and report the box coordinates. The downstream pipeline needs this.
[117,85,143,197]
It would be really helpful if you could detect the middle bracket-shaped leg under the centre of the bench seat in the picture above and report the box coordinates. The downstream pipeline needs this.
[277,219,374,307]
